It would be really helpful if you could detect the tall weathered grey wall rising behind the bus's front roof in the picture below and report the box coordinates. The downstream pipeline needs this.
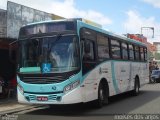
[7,2,52,38]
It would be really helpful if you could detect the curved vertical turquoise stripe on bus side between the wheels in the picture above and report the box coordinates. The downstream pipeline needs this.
[111,61,119,94]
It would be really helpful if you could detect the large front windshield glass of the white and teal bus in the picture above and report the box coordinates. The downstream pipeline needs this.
[20,35,80,73]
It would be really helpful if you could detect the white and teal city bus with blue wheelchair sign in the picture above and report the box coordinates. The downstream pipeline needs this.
[17,19,149,107]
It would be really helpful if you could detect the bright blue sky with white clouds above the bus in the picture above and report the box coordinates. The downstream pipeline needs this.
[0,0,160,43]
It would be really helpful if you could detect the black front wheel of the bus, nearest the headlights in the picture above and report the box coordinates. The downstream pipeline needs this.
[94,82,109,108]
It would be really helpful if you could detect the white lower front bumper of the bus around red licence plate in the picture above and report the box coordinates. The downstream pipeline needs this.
[17,87,83,104]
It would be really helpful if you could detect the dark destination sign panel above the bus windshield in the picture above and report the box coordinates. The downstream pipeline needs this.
[19,21,77,39]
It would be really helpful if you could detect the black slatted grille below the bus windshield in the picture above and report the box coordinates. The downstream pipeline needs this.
[20,76,65,84]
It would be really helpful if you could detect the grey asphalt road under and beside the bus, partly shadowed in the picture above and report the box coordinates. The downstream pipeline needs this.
[13,83,160,120]
